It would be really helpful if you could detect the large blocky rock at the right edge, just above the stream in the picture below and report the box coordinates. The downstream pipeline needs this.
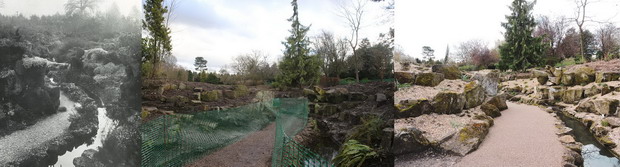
[576,97,620,115]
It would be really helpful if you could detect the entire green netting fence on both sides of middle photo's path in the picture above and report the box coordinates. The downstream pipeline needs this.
[140,98,331,167]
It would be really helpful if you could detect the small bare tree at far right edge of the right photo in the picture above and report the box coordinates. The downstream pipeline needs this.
[596,24,620,59]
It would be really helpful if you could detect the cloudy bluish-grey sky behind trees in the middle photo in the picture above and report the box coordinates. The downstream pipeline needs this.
[171,0,389,71]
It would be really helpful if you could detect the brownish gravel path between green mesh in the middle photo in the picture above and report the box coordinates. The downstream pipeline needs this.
[187,123,276,167]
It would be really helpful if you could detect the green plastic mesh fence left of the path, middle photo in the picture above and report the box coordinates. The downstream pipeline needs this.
[140,101,275,166]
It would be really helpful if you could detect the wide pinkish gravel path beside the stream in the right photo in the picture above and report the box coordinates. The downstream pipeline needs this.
[456,102,563,167]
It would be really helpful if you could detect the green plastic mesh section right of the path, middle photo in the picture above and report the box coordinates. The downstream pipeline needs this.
[271,99,332,167]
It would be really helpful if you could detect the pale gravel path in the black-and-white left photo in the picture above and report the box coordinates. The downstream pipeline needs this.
[0,92,75,166]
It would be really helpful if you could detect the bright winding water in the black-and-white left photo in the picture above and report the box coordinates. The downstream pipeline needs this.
[54,105,118,166]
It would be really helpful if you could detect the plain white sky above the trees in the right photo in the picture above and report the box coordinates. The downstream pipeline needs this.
[394,0,620,59]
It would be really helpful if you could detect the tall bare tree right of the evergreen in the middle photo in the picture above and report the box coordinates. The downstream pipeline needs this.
[338,0,367,82]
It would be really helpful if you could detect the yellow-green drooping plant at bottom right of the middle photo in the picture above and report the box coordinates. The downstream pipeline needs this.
[332,140,378,167]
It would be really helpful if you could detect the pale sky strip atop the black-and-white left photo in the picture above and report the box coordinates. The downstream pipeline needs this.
[0,0,142,17]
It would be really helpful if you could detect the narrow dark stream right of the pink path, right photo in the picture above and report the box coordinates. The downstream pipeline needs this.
[554,107,620,167]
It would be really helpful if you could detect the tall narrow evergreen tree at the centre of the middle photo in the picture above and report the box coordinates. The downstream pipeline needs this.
[276,0,321,87]
